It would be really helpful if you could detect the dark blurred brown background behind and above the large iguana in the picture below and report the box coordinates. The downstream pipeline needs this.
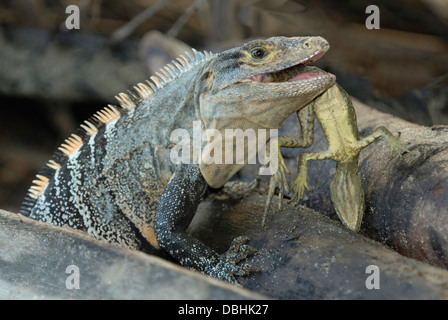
[0,0,448,212]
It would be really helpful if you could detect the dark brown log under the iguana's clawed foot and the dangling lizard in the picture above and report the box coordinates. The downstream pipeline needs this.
[190,195,448,299]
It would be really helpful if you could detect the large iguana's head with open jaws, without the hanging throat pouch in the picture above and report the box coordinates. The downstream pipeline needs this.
[200,37,335,130]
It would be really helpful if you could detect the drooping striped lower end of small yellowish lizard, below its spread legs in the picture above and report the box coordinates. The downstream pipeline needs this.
[330,158,364,232]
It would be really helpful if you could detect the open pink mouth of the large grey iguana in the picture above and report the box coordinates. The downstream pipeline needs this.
[242,51,325,83]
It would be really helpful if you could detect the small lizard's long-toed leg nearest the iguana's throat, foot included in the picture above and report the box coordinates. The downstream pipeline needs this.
[262,103,314,227]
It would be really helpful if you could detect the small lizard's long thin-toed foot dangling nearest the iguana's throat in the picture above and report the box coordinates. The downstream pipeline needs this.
[261,151,290,227]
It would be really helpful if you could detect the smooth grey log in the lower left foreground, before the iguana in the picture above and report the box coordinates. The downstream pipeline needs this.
[0,210,263,299]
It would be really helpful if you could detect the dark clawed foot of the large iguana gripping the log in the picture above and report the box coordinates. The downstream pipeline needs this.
[204,237,259,285]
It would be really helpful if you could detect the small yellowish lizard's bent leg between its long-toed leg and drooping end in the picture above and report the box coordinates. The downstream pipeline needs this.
[288,150,333,205]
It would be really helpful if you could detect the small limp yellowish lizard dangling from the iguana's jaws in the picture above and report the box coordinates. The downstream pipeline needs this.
[263,66,408,232]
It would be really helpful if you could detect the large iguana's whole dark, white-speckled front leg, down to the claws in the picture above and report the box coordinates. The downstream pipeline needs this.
[154,165,256,283]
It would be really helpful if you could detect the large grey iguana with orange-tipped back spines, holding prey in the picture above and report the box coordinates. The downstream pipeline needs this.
[21,37,335,282]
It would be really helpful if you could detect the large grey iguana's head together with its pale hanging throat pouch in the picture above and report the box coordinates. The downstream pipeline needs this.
[197,37,335,188]
